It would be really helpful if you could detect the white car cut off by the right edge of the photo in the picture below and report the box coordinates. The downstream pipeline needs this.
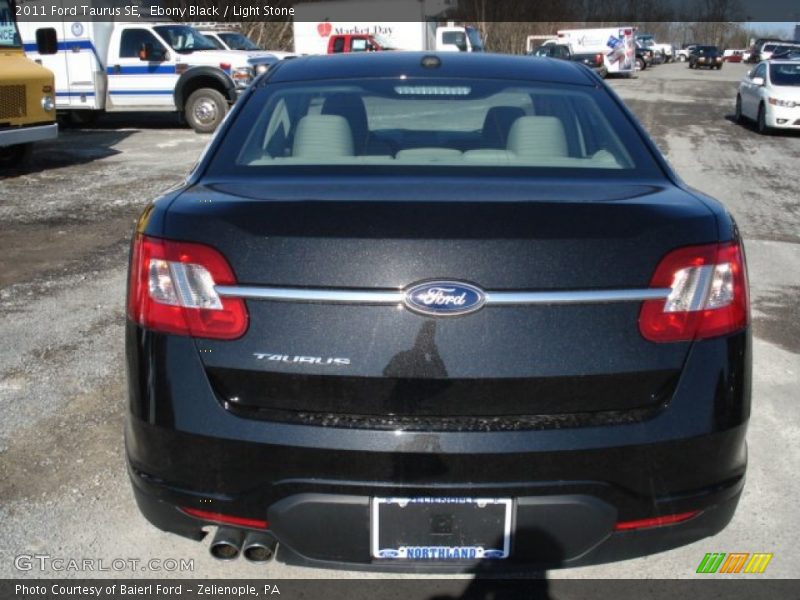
[736,60,800,133]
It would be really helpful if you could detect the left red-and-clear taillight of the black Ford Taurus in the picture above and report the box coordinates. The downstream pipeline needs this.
[128,234,248,340]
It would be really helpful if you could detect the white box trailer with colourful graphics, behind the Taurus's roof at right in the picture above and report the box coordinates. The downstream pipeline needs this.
[558,25,636,76]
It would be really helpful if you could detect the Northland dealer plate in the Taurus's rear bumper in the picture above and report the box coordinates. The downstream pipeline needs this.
[371,498,511,561]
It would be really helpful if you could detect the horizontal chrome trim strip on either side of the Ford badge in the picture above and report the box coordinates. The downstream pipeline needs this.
[215,285,672,306]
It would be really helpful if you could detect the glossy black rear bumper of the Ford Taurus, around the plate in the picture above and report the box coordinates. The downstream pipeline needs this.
[126,324,750,571]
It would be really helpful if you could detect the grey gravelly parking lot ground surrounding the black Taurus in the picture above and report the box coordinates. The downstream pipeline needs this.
[0,59,800,578]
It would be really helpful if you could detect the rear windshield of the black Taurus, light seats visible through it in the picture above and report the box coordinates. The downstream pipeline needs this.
[210,79,656,174]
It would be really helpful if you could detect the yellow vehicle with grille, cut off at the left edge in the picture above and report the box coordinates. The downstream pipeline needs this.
[0,0,58,169]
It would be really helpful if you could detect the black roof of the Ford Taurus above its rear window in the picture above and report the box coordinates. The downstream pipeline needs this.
[268,50,597,86]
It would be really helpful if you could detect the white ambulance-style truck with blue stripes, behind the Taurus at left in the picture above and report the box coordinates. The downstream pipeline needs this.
[19,21,274,133]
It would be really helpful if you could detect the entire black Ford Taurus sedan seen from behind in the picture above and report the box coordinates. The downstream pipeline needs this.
[126,53,751,570]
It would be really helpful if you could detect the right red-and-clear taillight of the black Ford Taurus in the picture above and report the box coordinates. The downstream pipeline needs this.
[639,242,750,342]
